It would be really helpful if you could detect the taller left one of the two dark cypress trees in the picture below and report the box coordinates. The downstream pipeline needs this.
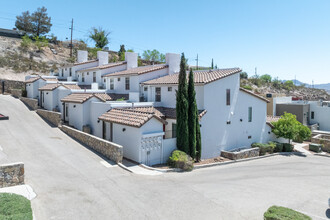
[176,53,190,154]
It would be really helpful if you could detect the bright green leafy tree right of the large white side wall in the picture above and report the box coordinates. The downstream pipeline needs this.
[272,112,305,143]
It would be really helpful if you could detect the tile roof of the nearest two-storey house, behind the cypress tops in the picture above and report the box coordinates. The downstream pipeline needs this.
[142,68,241,85]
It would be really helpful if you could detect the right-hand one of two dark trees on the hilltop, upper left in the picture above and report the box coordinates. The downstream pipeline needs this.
[31,7,52,36]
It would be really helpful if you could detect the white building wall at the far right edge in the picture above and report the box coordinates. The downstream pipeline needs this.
[309,102,330,131]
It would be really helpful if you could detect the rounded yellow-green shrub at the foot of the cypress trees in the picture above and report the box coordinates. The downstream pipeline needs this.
[167,150,194,171]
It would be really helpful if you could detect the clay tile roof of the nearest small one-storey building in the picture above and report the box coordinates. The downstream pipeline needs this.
[99,107,166,128]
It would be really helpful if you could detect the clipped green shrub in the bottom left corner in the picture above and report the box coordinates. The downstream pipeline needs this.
[0,193,32,220]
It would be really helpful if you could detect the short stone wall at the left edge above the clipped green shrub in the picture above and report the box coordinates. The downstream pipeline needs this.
[0,163,24,188]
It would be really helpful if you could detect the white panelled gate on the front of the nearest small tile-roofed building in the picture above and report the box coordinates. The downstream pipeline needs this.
[141,136,163,166]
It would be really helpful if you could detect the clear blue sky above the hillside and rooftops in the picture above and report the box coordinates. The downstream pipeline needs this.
[0,0,330,83]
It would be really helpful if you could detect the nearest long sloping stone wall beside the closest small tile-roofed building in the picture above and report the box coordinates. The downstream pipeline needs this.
[59,125,123,163]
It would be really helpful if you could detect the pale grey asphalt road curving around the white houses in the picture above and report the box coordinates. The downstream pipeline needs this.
[0,95,330,220]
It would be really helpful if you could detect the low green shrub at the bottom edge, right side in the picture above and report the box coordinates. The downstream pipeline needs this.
[264,206,312,220]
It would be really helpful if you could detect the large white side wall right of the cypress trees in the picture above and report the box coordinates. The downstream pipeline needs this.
[201,74,267,158]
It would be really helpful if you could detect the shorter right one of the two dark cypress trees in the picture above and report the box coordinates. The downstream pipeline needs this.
[188,69,198,158]
